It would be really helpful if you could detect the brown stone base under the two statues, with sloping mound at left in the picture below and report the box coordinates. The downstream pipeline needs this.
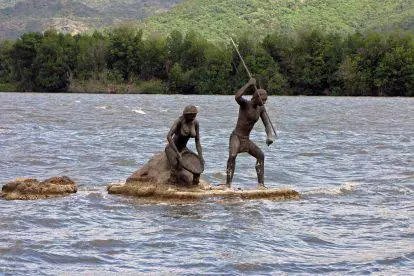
[107,152,300,200]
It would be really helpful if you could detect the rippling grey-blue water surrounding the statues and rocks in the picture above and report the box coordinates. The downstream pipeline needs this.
[0,93,414,275]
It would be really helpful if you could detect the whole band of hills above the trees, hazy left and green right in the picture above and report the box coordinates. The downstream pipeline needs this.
[0,0,414,40]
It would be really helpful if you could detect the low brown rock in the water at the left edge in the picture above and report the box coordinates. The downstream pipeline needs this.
[1,176,78,200]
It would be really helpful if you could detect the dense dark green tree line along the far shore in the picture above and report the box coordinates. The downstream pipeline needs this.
[0,26,414,96]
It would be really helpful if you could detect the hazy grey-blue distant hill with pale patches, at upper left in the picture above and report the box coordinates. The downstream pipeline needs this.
[0,0,183,38]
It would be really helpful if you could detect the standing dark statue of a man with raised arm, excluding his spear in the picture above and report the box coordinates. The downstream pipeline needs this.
[226,78,274,188]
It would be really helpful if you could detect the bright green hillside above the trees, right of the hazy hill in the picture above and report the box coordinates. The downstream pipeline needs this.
[139,0,414,40]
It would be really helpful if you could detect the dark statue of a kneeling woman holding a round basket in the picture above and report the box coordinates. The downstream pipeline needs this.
[165,105,204,186]
